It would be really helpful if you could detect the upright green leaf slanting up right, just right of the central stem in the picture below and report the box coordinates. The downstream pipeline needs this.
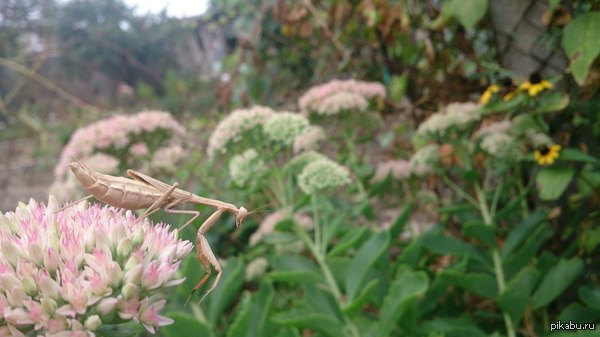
[346,231,390,302]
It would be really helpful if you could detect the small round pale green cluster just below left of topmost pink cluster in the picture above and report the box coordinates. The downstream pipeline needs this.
[263,112,309,145]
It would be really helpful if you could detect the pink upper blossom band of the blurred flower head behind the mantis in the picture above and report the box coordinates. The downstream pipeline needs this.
[54,111,187,179]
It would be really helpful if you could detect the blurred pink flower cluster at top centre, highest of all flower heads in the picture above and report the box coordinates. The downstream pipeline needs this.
[298,80,386,115]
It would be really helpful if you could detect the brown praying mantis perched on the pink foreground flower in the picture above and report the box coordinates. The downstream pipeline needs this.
[63,158,248,301]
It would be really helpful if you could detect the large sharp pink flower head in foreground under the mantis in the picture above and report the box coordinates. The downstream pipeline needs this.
[0,196,192,337]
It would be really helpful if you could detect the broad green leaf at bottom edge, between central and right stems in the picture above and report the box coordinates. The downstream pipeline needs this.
[377,271,429,337]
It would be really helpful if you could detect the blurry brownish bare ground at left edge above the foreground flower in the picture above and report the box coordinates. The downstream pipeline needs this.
[0,137,57,212]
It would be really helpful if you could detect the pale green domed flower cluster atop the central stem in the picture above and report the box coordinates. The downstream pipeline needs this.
[298,159,350,194]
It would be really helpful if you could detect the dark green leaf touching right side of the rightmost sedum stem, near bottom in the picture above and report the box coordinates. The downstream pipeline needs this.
[498,268,540,324]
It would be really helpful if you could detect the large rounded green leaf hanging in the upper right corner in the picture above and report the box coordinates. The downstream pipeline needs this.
[562,12,600,85]
